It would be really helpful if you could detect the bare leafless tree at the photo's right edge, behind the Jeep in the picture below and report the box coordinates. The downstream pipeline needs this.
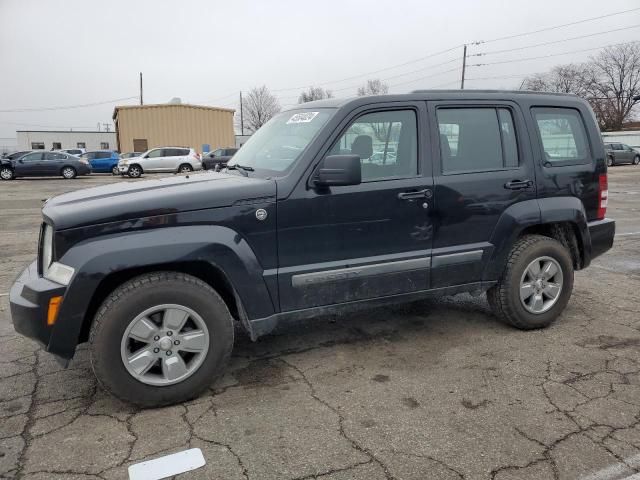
[589,42,640,131]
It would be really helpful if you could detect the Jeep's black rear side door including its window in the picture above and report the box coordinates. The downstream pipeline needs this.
[429,101,536,288]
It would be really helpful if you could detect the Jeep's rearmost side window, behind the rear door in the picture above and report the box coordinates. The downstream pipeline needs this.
[532,107,590,167]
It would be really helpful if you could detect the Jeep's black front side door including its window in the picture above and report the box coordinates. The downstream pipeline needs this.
[278,102,433,311]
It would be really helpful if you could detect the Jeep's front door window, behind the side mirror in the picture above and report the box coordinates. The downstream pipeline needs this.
[329,110,418,182]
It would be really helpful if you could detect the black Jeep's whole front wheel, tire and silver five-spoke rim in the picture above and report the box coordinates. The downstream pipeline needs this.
[89,272,233,407]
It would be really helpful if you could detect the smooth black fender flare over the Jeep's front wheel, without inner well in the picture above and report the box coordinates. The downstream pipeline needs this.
[49,225,275,358]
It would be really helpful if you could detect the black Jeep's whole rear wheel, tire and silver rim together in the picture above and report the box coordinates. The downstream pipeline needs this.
[487,235,573,330]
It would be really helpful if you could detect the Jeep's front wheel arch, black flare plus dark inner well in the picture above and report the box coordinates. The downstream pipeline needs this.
[49,225,275,358]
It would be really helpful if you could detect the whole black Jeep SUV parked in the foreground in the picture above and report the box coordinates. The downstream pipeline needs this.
[10,91,615,406]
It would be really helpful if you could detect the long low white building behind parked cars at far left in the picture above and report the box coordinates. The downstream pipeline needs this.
[16,130,117,150]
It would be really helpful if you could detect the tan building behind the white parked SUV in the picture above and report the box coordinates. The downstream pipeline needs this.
[113,103,235,153]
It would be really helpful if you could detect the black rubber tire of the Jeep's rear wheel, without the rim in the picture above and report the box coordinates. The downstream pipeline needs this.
[487,235,573,330]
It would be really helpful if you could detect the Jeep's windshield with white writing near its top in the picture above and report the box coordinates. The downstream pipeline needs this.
[228,108,335,174]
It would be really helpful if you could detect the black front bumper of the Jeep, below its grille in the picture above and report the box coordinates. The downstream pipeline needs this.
[9,262,66,353]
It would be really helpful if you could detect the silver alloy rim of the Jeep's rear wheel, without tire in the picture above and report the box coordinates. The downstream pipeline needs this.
[520,257,564,314]
